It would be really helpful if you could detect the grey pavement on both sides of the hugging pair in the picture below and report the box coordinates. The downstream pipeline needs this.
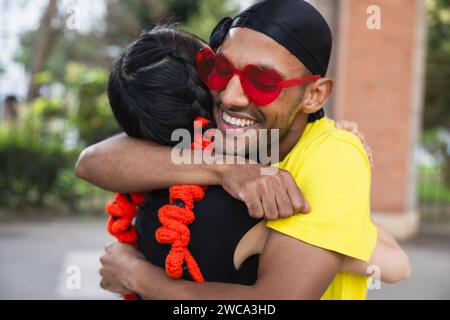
[0,218,450,299]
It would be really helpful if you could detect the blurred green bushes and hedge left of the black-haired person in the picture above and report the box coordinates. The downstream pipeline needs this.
[0,63,119,213]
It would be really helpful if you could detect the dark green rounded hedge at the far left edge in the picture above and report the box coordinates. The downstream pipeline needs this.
[0,122,68,208]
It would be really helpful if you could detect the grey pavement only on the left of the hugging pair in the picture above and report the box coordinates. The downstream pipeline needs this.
[0,219,116,299]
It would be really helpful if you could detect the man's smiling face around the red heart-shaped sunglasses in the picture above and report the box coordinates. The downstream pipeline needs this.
[212,28,309,153]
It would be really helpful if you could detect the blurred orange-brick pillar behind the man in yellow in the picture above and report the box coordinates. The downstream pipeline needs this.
[310,0,426,238]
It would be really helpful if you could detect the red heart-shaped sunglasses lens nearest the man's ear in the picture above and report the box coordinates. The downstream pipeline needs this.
[242,65,282,106]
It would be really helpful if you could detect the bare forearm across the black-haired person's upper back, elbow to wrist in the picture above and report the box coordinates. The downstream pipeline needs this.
[76,134,222,192]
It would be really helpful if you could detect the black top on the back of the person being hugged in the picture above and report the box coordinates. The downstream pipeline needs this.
[136,186,261,285]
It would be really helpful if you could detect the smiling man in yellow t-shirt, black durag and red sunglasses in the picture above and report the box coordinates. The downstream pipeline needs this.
[78,0,412,299]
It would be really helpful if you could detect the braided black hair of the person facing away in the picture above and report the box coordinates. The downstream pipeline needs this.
[107,25,212,145]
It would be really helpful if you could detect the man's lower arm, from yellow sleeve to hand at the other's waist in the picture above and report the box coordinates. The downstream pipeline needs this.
[128,230,343,300]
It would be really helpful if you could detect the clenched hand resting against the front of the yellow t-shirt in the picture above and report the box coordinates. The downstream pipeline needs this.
[220,164,311,220]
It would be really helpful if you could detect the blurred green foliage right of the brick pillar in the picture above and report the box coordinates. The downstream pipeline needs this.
[418,0,450,203]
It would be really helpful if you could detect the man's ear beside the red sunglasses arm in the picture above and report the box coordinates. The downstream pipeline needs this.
[302,78,333,114]
